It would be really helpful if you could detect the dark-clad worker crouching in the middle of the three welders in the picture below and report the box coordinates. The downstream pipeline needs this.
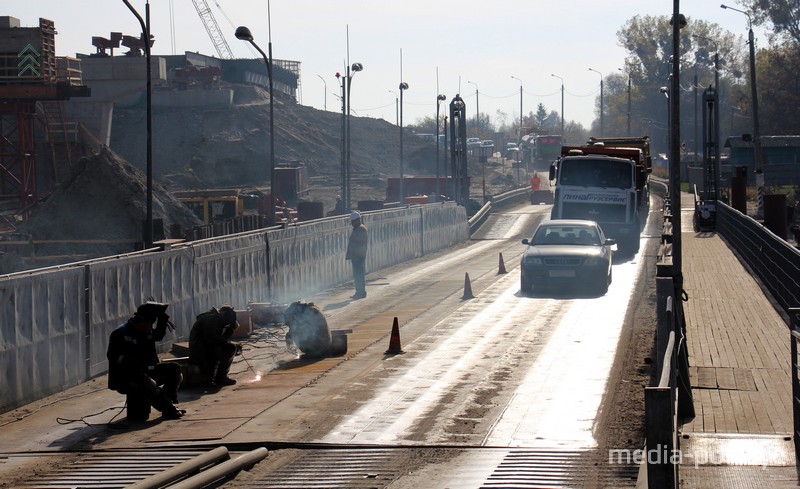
[189,305,241,387]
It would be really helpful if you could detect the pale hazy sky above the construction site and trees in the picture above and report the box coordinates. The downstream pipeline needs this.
[7,0,767,127]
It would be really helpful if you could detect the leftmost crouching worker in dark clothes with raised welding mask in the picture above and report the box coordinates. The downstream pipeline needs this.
[107,302,184,421]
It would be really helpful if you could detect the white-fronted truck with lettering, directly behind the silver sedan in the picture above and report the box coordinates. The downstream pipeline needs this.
[549,146,641,254]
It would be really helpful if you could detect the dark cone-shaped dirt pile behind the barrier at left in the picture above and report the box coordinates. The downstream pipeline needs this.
[17,145,201,256]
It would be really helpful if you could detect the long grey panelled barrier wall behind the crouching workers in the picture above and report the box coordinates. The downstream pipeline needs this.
[0,204,469,412]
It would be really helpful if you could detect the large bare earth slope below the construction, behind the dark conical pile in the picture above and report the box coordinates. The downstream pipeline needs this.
[110,85,436,190]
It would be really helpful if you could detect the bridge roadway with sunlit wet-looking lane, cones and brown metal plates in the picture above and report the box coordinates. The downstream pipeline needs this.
[0,195,660,488]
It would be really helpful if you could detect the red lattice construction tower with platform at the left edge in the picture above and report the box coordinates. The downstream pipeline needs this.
[0,17,90,217]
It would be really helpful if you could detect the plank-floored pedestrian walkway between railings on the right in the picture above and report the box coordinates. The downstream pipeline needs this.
[680,194,798,489]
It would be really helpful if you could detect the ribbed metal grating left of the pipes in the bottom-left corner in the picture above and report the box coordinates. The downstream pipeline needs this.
[3,450,204,489]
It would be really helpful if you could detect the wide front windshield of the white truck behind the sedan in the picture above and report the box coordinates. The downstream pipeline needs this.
[558,156,633,188]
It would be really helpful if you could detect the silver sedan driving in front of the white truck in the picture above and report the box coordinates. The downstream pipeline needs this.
[520,219,616,294]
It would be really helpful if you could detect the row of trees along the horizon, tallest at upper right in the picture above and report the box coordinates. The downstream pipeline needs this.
[416,0,800,153]
